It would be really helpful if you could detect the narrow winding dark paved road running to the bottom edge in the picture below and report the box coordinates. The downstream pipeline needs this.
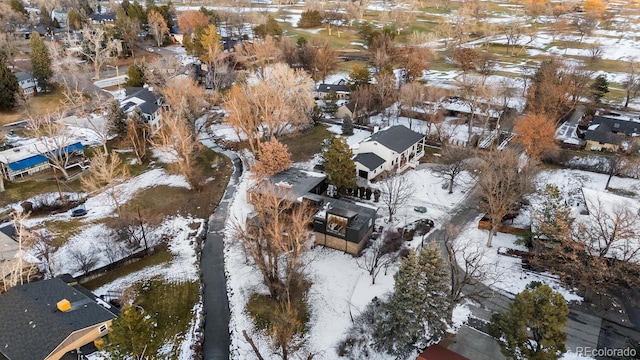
[200,139,242,360]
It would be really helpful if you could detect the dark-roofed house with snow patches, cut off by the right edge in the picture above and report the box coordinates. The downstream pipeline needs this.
[584,113,640,151]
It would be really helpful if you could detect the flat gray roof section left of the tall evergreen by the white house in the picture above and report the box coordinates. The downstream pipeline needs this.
[255,168,326,201]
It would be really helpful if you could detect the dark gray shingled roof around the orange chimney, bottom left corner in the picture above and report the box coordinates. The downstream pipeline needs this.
[0,278,116,360]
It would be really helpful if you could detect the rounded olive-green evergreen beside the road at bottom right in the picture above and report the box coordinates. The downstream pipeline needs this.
[489,282,569,360]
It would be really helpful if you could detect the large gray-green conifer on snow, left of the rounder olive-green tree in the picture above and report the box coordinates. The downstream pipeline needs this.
[373,244,450,359]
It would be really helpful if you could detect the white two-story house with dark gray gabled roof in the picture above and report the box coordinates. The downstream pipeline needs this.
[353,125,425,180]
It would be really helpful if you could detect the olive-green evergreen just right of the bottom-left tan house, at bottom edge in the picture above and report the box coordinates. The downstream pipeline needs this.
[104,306,157,359]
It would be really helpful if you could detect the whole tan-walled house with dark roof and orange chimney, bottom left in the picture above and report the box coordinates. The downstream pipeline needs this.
[0,278,118,360]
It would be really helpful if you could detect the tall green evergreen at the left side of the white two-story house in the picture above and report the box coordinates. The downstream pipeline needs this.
[323,138,356,193]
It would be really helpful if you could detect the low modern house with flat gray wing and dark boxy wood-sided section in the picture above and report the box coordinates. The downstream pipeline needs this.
[247,168,377,256]
